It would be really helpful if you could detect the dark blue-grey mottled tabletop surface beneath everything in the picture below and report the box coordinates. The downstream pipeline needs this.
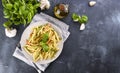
[0,0,120,73]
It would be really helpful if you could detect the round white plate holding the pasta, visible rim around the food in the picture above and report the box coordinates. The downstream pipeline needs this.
[20,21,63,64]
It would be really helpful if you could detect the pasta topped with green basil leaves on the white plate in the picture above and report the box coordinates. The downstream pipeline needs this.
[24,23,61,62]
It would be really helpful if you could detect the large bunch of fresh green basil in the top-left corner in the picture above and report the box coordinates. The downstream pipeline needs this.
[2,0,40,28]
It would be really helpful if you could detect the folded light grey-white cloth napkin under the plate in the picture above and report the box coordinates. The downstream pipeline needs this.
[13,13,70,71]
